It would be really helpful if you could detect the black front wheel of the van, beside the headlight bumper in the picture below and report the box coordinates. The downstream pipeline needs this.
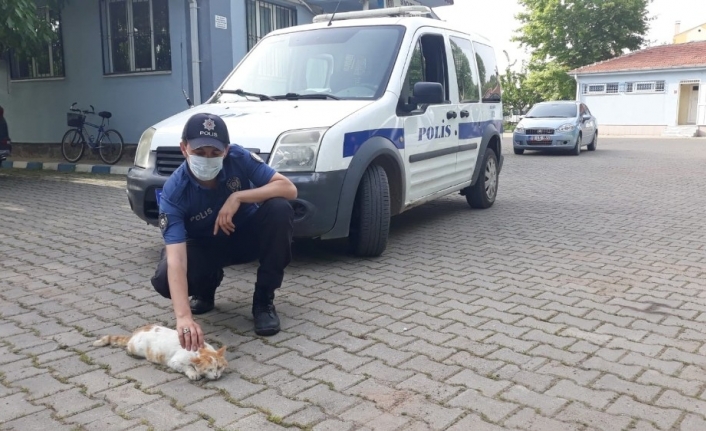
[349,165,390,257]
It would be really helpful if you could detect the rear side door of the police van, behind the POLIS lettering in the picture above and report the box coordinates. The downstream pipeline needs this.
[449,34,482,184]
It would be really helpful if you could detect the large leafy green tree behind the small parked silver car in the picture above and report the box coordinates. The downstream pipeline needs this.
[513,0,649,70]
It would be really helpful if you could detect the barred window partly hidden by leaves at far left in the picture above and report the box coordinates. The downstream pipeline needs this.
[10,7,64,80]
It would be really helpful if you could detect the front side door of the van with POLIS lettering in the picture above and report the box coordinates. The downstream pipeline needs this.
[398,29,459,203]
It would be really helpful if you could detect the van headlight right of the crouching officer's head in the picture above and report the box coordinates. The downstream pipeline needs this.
[269,129,327,172]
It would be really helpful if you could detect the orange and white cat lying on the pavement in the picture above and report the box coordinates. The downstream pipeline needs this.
[93,325,228,380]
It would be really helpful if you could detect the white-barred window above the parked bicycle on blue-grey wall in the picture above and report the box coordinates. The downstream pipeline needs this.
[101,0,172,75]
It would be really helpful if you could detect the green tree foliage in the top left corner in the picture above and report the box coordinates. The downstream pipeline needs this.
[0,0,65,57]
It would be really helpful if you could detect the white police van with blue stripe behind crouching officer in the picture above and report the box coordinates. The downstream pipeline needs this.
[127,6,503,256]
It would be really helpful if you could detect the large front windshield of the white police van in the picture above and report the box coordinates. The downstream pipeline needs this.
[214,26,404,103]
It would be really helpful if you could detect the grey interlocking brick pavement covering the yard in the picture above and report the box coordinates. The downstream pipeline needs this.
[0,138,706,431]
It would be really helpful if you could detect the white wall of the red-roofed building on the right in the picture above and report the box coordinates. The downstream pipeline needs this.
[578,68,706,126]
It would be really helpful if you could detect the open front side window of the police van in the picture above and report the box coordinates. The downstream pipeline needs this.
[399,34,449,111]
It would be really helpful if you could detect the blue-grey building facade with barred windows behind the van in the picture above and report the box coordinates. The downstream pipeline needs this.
[0,0,316,144]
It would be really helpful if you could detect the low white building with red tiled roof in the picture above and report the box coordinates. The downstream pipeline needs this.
[569,41,706,136]
